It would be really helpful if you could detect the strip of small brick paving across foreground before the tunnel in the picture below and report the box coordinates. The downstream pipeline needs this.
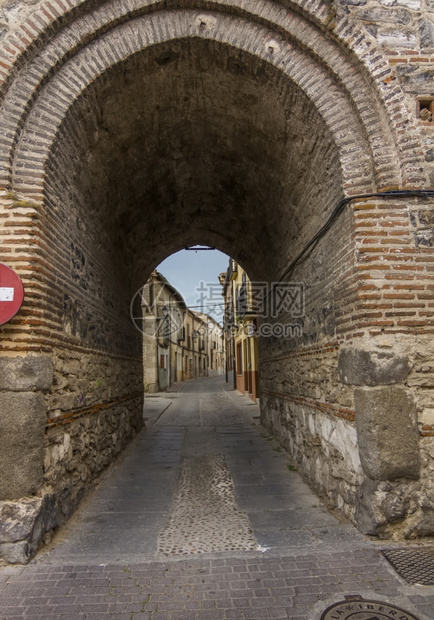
[0,549,434,620]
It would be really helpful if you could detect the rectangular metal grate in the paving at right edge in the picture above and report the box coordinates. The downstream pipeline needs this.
[382,548,434,586]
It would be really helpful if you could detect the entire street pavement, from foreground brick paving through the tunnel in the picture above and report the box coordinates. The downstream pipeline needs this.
[0,377,434,620]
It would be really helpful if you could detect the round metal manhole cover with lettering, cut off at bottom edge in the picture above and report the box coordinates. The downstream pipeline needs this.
[321,596,418,620]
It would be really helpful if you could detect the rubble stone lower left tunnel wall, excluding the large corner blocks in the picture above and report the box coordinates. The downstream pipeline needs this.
[44,349,143,516]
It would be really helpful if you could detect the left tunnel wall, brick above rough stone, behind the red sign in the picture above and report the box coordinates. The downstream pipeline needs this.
[0,177,143,562]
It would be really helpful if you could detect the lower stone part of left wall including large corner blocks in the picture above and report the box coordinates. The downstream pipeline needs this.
[0,349,143,562]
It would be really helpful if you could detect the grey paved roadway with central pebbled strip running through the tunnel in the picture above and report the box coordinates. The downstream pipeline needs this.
[39,377,364,563]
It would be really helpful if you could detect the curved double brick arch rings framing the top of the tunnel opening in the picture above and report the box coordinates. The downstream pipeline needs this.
[2,0,420,191]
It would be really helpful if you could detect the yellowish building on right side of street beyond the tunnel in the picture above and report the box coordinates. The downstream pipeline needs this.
[219,258,259,401]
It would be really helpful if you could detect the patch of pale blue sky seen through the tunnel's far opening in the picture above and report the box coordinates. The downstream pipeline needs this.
[157,250,229,323]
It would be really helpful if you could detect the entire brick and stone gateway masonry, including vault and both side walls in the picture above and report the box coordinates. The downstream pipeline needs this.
[0,0,434,560]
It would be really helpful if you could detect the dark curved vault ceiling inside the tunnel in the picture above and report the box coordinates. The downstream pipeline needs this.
[47,39,341,286]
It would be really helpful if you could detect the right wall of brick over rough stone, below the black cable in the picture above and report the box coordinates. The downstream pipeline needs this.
[261,194,434,538]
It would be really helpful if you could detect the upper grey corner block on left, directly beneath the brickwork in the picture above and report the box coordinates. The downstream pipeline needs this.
[0,355,53,392]
